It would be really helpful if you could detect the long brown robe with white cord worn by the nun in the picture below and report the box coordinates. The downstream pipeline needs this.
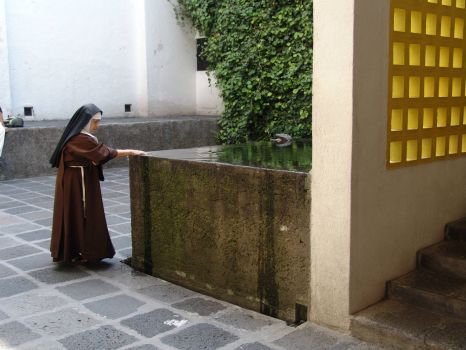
[50,134,117,261]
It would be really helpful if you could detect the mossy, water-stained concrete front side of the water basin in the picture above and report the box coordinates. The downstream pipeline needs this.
[130,156,310,321]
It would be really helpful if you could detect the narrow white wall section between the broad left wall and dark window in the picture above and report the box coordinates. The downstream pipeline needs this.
[146,0,196,116]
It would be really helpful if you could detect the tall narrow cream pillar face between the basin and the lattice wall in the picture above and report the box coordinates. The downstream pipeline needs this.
[310,0,354,329]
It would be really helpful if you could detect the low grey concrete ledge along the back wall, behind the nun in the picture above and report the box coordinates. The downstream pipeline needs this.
[0,116,217,180]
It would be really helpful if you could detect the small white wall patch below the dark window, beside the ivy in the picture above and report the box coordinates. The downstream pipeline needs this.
[196,71,224,115]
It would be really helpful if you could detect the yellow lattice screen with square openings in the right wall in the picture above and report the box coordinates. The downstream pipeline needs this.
[387,0,466,168]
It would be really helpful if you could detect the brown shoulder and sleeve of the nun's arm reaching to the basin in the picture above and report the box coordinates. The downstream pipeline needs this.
[65,134,117,165]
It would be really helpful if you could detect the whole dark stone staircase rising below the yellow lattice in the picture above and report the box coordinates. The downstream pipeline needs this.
[352,218,466,350]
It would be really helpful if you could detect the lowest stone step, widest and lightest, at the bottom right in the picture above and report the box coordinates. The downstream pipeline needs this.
[351,300,466,350]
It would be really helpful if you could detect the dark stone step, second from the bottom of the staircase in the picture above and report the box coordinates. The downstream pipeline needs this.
[387,270,466,321]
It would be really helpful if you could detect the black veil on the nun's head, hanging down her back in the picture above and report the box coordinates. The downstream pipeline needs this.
[49,103,102,168]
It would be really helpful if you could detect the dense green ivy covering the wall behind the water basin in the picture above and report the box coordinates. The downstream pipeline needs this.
[176,0,313,143]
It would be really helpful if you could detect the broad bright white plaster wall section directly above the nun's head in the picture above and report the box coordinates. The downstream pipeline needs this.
[6,0,147,119]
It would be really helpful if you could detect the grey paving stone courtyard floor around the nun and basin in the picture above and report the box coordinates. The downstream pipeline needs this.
[0,169,377,350]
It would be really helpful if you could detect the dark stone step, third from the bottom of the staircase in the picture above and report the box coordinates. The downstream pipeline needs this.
[418,240,466,279]
